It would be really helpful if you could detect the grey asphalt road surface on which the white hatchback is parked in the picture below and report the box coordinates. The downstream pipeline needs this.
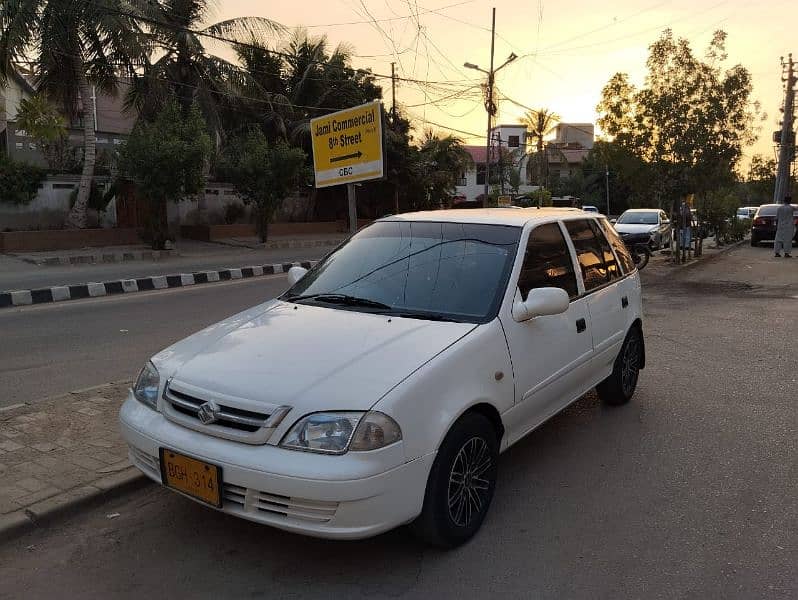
[0,241,798,599]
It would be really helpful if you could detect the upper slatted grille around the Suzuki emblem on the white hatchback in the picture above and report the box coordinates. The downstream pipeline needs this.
[163,381,291,444]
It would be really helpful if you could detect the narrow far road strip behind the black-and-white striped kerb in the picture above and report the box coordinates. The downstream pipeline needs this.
[0,246,333,291]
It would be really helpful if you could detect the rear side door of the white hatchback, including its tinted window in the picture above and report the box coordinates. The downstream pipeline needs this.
[565,219,629,380]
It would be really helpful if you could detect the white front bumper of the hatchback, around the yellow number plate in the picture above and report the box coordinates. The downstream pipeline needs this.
[119,397,435,539]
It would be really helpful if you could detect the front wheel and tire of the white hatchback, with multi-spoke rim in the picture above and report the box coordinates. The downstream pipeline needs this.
[411,412,499,548]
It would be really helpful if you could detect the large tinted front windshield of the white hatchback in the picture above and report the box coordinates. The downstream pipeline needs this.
[282,221,521,322]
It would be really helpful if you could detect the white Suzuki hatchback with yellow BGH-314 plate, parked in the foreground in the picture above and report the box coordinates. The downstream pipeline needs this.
[120,209,645,546]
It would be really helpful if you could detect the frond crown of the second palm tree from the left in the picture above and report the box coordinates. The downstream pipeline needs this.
[127,0,284,134]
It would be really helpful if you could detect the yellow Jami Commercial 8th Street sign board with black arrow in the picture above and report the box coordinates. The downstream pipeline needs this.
[310,100,385,188]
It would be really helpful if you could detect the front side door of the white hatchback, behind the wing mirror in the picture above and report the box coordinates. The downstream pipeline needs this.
[500,222,593,443]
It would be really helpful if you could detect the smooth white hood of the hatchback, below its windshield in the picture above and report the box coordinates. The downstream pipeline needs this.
[153,301,476,412]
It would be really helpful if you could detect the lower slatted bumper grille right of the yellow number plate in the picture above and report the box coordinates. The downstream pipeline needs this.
[223,483,338,523]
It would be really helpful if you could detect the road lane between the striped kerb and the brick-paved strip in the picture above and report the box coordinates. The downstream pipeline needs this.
[0,275,288,407]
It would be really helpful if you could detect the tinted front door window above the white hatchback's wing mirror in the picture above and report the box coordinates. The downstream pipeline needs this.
[518,223,579,299]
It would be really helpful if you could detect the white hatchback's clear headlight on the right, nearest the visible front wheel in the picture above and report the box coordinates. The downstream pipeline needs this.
[280,411,402,454]
